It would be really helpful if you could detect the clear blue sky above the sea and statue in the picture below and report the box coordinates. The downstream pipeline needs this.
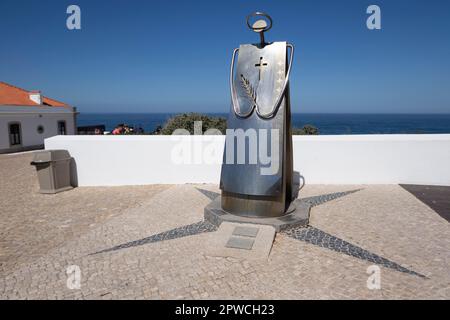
[0,0,450,113]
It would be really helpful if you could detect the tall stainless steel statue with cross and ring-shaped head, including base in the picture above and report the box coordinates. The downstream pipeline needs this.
[205,12,309,230]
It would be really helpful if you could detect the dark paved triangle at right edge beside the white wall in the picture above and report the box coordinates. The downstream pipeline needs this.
[400,184,450,222]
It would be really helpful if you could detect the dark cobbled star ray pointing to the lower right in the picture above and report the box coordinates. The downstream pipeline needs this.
[283,227,425,278]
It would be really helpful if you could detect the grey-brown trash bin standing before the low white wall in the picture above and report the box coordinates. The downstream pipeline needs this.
[30,150,73,193]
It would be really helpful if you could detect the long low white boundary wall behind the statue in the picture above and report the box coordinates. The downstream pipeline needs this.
[45,134,450,186]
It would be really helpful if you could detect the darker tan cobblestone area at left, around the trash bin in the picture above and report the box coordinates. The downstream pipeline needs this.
[0,152,168,273]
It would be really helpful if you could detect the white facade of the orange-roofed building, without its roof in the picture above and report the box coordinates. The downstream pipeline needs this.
[0,106,75,150]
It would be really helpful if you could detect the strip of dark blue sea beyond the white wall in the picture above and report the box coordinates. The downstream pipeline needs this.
[77,112,450,135]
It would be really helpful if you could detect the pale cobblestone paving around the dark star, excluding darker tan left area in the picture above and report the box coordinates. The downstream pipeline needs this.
[0,180,450,299]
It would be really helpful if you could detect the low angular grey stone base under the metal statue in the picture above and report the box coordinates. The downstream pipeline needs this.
[204,196,311,232]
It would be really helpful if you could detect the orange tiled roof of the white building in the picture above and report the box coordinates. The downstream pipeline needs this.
[0,81,68,107]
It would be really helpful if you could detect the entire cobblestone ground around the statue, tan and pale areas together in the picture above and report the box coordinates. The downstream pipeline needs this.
[0,156,450,299]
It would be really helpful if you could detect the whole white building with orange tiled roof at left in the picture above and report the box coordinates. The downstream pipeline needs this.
[0,82,77,153]
